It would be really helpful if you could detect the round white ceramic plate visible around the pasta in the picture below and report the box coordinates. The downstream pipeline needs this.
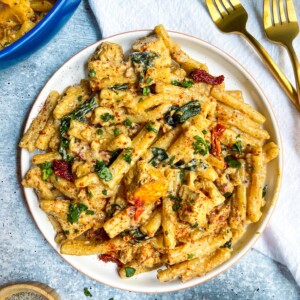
[21,30,282,293]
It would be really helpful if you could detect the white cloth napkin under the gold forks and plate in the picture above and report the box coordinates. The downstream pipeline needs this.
[89,0,300,285]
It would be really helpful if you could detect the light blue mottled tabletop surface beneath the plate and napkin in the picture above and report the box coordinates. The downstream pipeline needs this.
[0,1,300,300]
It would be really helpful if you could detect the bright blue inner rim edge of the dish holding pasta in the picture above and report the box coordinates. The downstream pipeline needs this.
[0,0,81,58]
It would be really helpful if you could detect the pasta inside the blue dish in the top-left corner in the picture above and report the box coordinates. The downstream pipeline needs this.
[0,0,56,50]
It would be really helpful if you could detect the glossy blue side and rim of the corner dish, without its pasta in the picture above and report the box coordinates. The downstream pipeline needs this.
[0,0,80,70]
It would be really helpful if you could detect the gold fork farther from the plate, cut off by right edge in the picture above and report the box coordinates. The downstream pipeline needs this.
[264,0,300,103]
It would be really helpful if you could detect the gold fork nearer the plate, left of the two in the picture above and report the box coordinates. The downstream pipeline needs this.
[206,0,300,112]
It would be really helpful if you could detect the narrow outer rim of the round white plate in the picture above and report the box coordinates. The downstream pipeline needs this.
[19,29,283,294]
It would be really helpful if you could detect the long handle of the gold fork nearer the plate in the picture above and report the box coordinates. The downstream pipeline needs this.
[241,29,300,112]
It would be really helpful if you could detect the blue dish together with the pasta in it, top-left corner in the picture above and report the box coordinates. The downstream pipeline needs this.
[0,0,80,69]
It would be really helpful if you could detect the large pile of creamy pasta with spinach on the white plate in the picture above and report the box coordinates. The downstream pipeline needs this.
[20,25,278,282]
